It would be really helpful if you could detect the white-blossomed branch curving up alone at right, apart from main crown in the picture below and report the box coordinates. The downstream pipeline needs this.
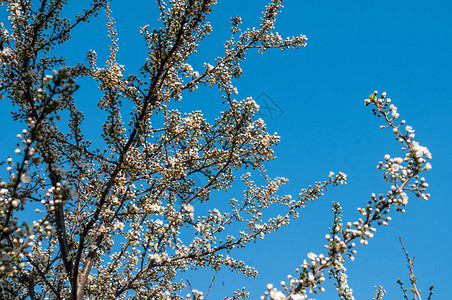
[262,91,432,300]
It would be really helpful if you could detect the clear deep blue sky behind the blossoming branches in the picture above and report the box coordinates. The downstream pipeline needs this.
[1,0,452,300]
